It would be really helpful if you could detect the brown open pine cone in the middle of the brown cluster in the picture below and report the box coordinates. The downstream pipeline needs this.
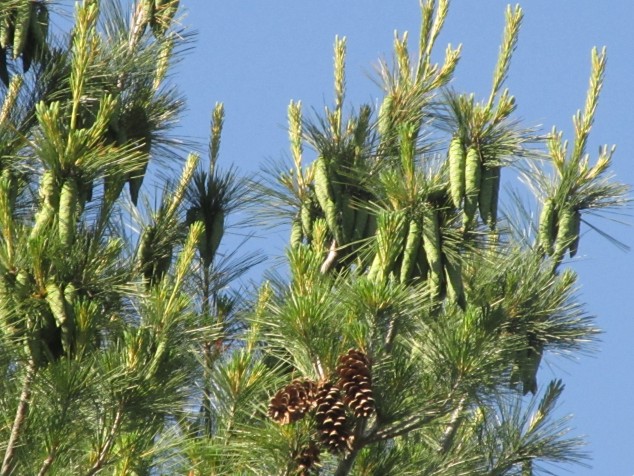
[315,382,353,453]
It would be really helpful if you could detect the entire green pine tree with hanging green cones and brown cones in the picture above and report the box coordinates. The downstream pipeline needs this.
[0,0,628,476]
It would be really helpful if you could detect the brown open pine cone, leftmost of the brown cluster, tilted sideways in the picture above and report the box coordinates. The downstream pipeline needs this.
[269,380,317,425]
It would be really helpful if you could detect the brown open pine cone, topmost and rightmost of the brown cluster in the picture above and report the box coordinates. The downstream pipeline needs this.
[337,349,374,418]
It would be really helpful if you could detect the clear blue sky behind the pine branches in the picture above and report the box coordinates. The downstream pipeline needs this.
[176,0,634,476]
